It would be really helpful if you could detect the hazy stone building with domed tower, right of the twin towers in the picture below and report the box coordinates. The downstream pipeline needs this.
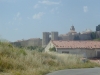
[59,26,92,40]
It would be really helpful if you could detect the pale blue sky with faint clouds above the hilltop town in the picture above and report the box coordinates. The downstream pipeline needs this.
[0,0,100,42]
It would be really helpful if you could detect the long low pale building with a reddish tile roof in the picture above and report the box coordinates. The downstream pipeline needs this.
[45,41,100,58]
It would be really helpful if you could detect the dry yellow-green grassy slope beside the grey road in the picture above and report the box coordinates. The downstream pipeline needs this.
[0,42,98,75]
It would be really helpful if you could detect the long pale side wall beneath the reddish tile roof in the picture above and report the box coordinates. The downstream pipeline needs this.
[57,48,96,58]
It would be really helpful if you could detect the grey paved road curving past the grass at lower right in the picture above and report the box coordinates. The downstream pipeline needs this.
[47,68,100,75]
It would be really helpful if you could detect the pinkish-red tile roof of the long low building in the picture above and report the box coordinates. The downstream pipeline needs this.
[52,41,100,49]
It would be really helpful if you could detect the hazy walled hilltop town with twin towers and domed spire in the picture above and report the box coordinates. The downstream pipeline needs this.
[11,24,100,47]
